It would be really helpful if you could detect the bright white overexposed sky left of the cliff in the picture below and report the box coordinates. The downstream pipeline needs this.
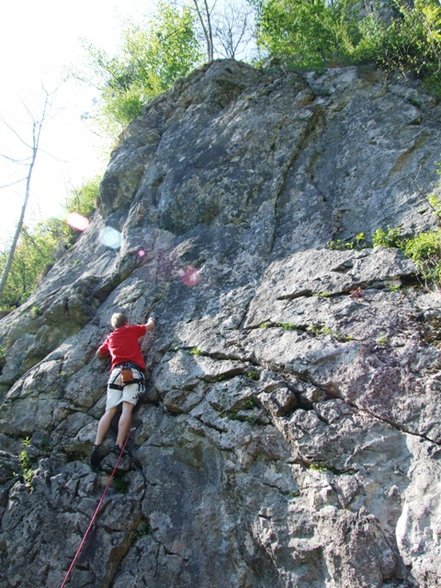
[0,0,157,249]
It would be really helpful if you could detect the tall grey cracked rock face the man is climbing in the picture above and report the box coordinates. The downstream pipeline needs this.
[0,61,441,588]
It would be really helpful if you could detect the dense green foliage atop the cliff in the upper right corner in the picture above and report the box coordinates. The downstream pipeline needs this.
[253,0,441,95]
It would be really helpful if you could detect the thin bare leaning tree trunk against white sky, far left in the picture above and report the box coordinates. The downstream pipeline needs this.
[0,90,49,297]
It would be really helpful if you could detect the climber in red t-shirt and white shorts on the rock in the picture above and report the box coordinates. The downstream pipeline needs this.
[90,312,155,467]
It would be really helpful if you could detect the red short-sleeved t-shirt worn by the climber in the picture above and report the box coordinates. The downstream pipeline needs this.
[98,325,147,370]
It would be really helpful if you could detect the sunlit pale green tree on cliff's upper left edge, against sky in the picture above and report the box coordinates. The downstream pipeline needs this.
[84,2,201,135]
